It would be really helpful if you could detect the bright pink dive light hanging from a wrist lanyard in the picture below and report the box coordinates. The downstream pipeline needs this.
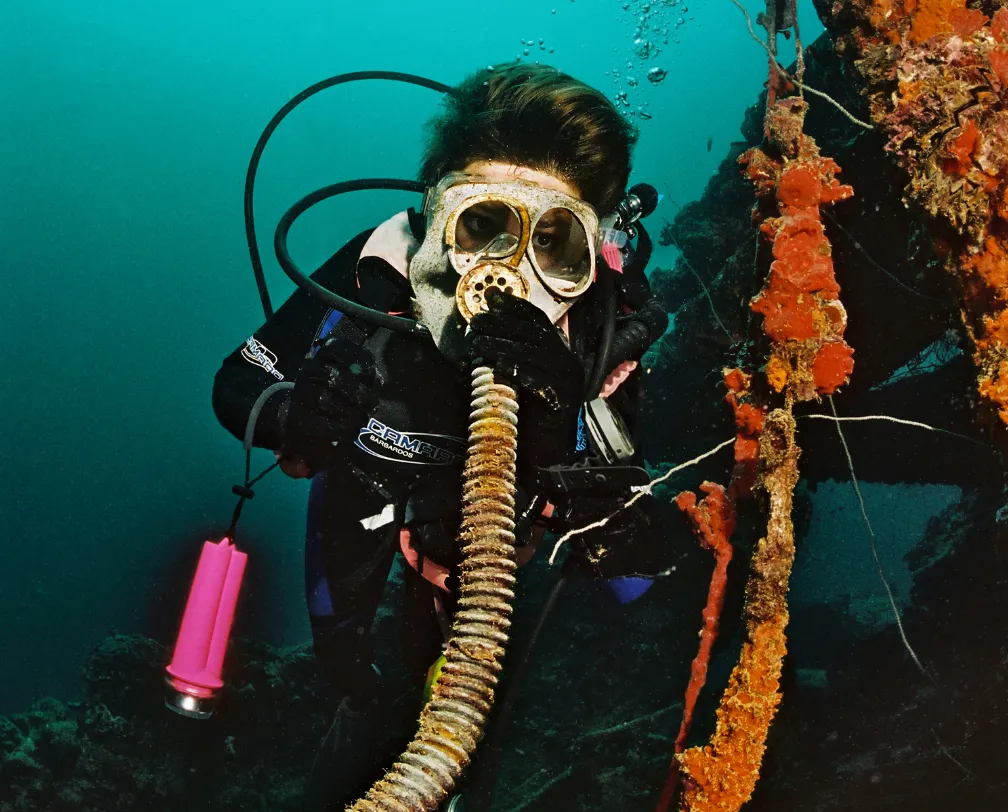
[164,537,248,719]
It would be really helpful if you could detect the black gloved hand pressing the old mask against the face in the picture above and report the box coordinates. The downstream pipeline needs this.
[466,288,585,479]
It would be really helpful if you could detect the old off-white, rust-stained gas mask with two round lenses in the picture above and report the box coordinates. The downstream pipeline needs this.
[409,172,600,351]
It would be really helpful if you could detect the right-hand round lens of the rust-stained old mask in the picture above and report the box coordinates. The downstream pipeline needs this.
[529,209,592,295]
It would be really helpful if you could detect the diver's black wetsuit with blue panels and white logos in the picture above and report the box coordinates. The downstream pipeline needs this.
[214,225,653,692]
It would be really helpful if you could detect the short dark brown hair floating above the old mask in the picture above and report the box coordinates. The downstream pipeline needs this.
[420,64,637,215]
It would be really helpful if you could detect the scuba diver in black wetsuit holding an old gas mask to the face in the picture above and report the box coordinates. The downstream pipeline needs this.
[213,64,667,810]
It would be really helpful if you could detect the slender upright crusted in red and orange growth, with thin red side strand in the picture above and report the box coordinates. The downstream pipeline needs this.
[658,87,854,812]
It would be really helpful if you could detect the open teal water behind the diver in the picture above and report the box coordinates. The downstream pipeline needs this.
[0,0,818,710]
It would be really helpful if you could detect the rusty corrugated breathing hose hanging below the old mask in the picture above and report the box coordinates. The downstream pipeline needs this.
[348,367,518,812]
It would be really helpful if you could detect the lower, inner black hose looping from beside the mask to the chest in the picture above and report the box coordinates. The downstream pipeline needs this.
[273,177,427,333]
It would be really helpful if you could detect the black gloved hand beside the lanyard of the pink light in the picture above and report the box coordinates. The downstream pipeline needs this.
[280,336,378,472]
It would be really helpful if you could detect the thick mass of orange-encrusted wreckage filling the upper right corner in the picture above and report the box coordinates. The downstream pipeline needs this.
[824,0,1008,435]
